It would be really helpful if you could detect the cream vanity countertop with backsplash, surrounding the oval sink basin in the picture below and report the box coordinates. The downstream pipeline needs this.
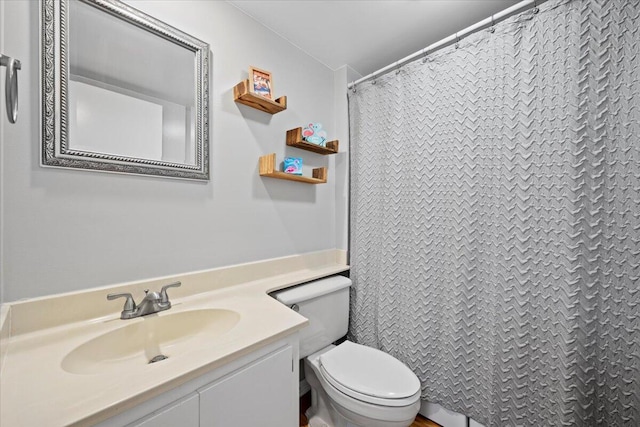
[0,251,349,427]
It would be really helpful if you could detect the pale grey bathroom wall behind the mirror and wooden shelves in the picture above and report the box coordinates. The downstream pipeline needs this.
[0,0,348,302]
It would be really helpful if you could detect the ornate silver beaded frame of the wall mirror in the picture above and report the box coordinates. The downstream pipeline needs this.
[40,0,209,180]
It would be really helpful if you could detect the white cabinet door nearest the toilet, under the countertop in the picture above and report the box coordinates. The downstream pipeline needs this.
[200,346,298,427]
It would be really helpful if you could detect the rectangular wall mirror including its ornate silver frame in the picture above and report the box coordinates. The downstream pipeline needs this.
[40,0,209,180]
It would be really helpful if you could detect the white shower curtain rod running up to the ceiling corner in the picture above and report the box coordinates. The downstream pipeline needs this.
[347,0,547,89]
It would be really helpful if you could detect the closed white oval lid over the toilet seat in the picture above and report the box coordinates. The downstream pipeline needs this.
[320,341,420,400]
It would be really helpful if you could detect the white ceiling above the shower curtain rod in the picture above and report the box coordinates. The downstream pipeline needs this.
[228,0,518,76]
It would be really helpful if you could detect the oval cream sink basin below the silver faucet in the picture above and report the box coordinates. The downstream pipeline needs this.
[62,309,240,375]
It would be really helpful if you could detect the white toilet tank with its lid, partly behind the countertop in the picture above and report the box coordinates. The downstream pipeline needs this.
[271,276,351,359]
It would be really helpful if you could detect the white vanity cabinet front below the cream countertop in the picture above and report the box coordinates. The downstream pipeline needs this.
[97,334,299,427]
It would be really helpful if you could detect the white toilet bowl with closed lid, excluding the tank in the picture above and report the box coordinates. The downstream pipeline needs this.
[304,341,420,427]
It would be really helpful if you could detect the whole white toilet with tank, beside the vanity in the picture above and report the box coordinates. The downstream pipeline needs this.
[273,276,420,427]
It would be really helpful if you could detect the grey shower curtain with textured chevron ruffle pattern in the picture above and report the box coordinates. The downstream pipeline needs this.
[349,0,640,427]
